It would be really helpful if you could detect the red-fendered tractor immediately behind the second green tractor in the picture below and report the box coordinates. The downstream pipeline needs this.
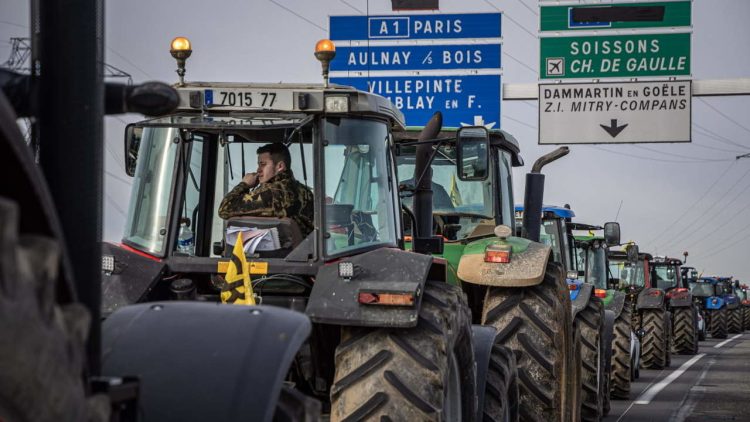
[608,251,672,369]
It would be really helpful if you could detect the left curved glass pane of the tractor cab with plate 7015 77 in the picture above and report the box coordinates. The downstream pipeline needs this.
[123,127,180,255]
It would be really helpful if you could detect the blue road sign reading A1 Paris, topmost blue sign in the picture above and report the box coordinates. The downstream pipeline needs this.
[329,13,502,41]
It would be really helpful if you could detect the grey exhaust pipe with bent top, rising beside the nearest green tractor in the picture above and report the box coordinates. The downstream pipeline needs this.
[523,147,570,242]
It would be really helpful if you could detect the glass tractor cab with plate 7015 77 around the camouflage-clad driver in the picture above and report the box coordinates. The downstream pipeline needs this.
[103,39,424,314]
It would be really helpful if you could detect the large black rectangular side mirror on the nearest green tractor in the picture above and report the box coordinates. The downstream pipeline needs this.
[456,126,490,180]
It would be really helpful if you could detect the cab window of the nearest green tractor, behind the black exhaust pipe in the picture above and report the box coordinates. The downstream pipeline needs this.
[397,144,496,241]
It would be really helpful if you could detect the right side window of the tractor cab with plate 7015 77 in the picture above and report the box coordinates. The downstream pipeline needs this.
[323,118,398,256]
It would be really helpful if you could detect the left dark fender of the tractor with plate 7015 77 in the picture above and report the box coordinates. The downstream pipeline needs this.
[102,243,167,317]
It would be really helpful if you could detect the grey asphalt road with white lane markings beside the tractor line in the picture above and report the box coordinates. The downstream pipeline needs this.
[604,332,750,422]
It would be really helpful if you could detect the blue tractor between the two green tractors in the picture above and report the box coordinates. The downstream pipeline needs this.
[515,205,620,421]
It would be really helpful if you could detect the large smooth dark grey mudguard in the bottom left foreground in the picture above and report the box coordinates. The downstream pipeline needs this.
[102,301,311,421]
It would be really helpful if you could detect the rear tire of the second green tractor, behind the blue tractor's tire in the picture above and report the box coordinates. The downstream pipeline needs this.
[610,303,633,400]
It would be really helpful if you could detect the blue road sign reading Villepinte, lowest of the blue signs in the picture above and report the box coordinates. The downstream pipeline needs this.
[331,75,501,128]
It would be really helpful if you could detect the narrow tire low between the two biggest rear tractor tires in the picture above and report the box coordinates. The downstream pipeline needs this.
[482,344,519,422]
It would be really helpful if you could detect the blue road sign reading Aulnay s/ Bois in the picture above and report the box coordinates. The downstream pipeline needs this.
[331,44,501,71]
